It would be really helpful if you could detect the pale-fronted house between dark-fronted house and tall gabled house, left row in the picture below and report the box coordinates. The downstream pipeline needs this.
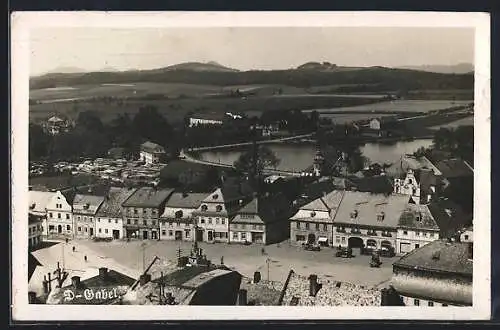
[160,192,209,241]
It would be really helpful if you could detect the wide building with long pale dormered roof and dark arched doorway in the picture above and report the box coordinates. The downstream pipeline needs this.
[333,191,410,249]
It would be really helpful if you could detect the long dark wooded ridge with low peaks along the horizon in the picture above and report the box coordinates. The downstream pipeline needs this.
[30,62,474,91]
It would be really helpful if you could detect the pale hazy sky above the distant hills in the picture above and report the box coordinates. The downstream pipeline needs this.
[30,27,474,75]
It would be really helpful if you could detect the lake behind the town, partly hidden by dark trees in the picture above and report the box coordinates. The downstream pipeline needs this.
[195,139,432,171]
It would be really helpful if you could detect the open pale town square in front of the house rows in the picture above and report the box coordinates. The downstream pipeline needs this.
[72,240,397,287]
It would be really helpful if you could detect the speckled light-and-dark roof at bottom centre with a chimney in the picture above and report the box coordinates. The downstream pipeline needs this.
[282,273,382,306]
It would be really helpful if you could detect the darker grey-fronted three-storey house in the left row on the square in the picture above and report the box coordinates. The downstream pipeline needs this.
[122,187,173,240]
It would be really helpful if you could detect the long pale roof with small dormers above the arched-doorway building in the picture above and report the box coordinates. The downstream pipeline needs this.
[333,191,410,228]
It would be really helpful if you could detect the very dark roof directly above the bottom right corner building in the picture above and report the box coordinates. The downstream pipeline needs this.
[428,199,472,237]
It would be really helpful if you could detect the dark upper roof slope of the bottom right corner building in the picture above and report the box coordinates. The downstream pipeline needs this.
[393,239,473,277]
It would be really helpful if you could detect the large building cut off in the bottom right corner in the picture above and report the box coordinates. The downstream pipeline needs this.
[391,239,473,307]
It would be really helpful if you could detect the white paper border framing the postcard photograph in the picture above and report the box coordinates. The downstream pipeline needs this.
[11,12,491,321]
